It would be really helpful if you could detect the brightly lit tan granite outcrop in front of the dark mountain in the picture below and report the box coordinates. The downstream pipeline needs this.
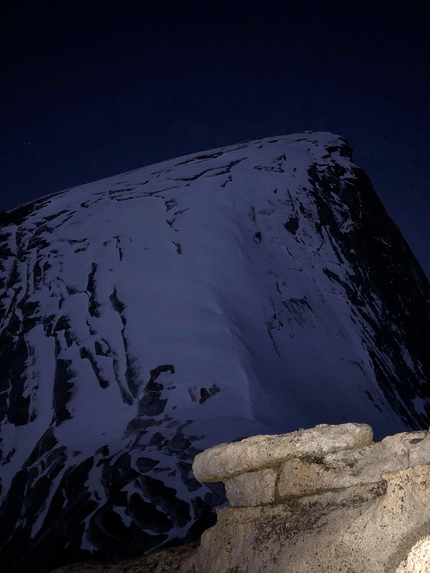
[186,424,430,573]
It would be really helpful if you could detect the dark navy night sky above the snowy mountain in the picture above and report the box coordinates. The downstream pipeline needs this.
[0,0,430,277]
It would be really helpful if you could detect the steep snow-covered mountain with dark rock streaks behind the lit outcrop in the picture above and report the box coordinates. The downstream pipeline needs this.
[0,132,430,573]
